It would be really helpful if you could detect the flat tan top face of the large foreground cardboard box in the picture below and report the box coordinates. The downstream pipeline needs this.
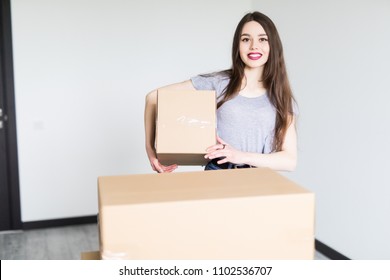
[98,168,308,205]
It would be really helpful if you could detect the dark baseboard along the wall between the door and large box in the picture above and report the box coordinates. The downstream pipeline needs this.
[22,215,97,229]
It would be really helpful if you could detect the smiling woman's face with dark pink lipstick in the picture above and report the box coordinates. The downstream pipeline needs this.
[240,21,270,68]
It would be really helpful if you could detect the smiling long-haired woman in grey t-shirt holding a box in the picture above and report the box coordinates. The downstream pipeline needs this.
[145,12,297,173]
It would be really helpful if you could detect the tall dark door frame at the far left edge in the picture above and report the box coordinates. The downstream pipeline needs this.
[0,0,22,230]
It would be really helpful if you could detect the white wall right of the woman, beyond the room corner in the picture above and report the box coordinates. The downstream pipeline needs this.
[253,0,390,259]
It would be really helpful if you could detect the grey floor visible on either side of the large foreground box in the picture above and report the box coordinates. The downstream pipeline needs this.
[0,224,328,260]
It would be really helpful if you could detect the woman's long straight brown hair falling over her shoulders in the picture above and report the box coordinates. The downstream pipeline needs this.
[217,12,295,152]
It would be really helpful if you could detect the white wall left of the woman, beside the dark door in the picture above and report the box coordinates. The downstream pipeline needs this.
[11,0,252,222]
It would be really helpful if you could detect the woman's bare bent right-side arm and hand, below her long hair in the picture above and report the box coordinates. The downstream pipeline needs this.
[205,117,297,171]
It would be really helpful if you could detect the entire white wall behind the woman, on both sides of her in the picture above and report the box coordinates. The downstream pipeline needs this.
[11,0,390,259]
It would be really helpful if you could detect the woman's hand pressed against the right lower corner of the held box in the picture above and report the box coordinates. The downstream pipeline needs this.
[204,136,244,164]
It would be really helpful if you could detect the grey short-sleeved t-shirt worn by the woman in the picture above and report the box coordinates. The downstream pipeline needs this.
[191,74,276,154]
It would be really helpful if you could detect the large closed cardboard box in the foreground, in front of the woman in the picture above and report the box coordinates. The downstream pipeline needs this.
[98,168,314,259]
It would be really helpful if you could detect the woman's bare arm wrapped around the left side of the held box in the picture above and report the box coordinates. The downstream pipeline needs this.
[144,80,195,173]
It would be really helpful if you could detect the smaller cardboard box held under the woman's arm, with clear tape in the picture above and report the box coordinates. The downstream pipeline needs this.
[156,90,216,165]
